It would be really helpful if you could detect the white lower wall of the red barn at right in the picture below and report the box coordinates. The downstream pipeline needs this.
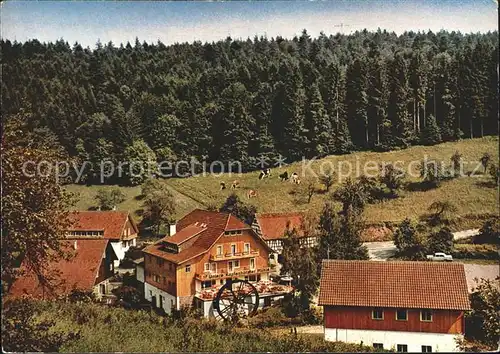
[325,328,461,353]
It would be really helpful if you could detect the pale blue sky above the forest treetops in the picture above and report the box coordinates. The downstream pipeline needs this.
[0,0,498,48]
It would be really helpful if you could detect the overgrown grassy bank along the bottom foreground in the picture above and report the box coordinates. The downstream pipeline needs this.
[3,302,384,352]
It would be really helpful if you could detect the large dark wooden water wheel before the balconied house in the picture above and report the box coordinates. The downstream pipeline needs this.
[214,279,259,322]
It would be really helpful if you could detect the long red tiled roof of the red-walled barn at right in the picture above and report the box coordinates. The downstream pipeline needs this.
[319,260,470,310]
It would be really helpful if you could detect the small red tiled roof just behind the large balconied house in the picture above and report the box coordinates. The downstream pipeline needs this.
[255,212,304,241]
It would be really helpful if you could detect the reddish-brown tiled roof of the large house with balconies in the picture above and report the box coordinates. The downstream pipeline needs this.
[144,209,268,263]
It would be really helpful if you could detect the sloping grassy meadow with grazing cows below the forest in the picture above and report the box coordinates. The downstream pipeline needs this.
[67,137,499,229]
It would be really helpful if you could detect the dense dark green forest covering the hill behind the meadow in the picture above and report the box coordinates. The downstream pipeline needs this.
[1,30,498,183]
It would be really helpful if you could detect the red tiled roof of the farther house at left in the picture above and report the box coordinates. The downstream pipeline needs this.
[70,210,138,239]
